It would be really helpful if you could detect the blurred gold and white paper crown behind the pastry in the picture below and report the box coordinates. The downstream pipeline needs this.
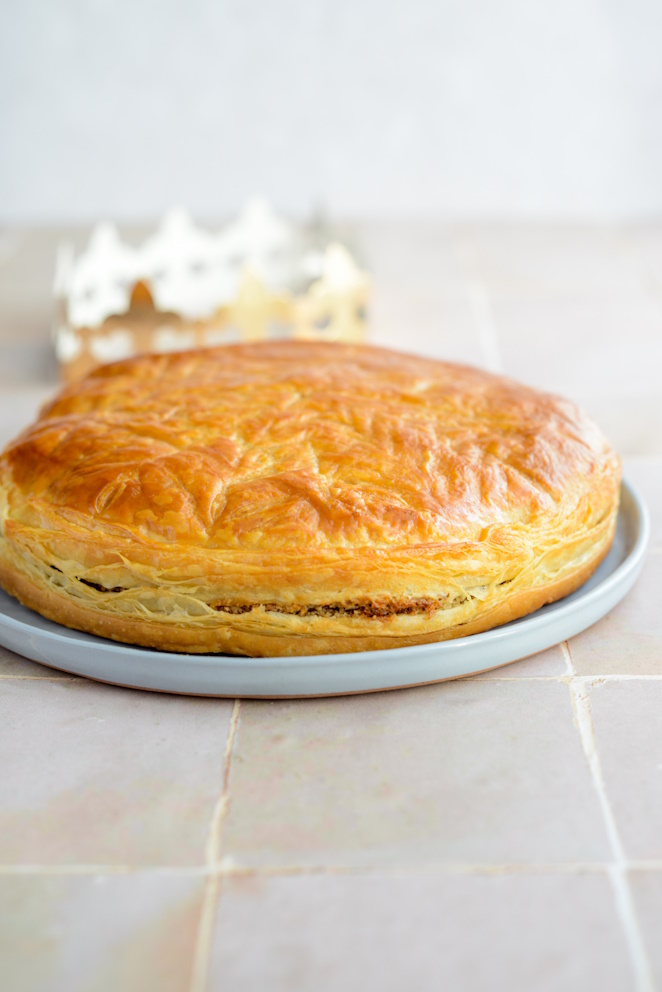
[54,200,370,380]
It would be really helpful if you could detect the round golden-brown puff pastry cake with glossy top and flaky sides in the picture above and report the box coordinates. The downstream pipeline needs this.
[0,341,620,655]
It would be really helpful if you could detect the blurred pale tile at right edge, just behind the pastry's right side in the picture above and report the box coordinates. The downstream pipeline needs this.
[493,293,662,402]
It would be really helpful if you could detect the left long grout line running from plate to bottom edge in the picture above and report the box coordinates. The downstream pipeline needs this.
[190,699,241,992]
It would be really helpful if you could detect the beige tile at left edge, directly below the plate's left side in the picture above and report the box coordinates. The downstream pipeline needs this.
[0,679,232,865]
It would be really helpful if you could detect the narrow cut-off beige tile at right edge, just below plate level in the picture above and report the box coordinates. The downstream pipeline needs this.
[590,680,662,861]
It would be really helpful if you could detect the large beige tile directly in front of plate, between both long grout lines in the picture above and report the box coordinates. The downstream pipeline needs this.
[223,679,608,865]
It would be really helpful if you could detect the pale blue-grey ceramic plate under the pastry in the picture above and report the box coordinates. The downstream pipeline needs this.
[0,482,649,697]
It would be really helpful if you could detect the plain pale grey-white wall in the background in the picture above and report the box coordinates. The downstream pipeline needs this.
[0,0,662,223]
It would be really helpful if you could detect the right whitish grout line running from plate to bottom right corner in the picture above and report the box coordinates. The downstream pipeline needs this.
[561,641,655,992]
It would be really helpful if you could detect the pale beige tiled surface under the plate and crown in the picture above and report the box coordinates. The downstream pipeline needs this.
[0,223,662,992]
